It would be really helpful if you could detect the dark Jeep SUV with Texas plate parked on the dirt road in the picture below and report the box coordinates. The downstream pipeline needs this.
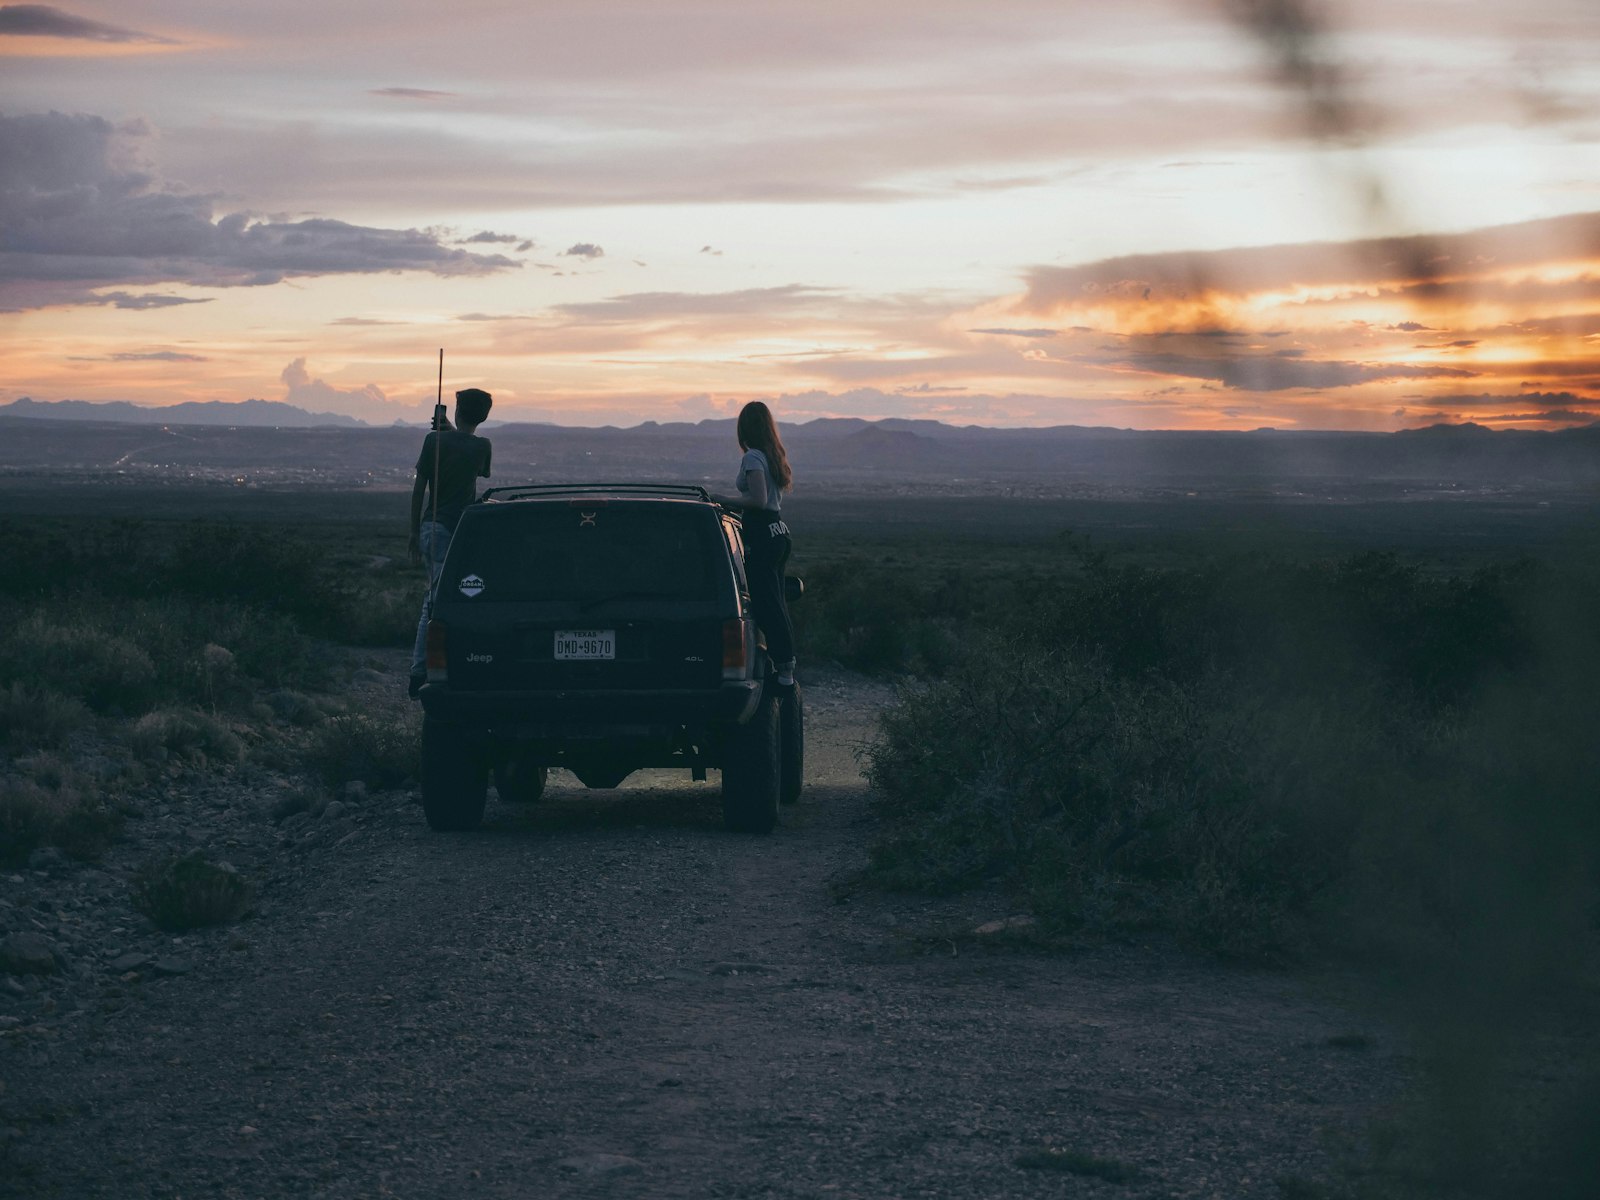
[421,485,805,834]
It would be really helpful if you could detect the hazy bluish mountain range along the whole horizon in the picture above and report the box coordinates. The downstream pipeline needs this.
[0,400,1600,499]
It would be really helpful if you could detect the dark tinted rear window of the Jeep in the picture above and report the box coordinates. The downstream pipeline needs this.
[442,501,728,603]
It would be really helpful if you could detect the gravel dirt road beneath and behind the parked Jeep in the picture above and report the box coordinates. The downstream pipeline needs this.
[0,675,1397,1198]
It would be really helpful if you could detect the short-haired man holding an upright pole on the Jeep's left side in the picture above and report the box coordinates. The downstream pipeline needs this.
[406,387,494,699]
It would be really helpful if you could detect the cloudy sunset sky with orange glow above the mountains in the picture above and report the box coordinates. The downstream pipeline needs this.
[0,0,1600,429]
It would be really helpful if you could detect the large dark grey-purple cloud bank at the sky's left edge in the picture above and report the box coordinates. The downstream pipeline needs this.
[0,112,518,307]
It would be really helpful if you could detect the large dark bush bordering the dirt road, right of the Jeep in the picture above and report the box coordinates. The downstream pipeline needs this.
[867,642,1330,955]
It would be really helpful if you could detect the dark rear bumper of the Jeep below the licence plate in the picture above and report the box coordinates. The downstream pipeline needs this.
[421,680,762,739]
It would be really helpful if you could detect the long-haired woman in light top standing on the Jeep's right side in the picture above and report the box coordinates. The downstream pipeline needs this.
[715,400,795,688]
